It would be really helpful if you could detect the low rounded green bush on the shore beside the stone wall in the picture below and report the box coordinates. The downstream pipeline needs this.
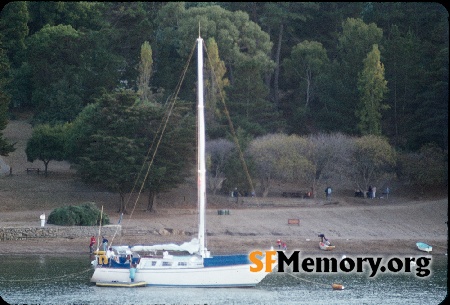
[47,202,109,226]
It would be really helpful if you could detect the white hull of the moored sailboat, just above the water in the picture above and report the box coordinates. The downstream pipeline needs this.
[91,265,268,287]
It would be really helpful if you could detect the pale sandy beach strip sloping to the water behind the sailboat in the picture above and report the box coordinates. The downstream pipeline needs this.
[0,199,448,256]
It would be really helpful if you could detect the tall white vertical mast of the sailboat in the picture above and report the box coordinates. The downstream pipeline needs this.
[197,36,207,257]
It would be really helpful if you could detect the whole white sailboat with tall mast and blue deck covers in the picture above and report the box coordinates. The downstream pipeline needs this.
[91,37,276,287]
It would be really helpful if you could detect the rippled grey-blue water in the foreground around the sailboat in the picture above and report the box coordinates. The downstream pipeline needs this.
[0,256,447,305]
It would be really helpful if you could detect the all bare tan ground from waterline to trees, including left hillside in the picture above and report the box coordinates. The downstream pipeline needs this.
[0,121,448,256]
